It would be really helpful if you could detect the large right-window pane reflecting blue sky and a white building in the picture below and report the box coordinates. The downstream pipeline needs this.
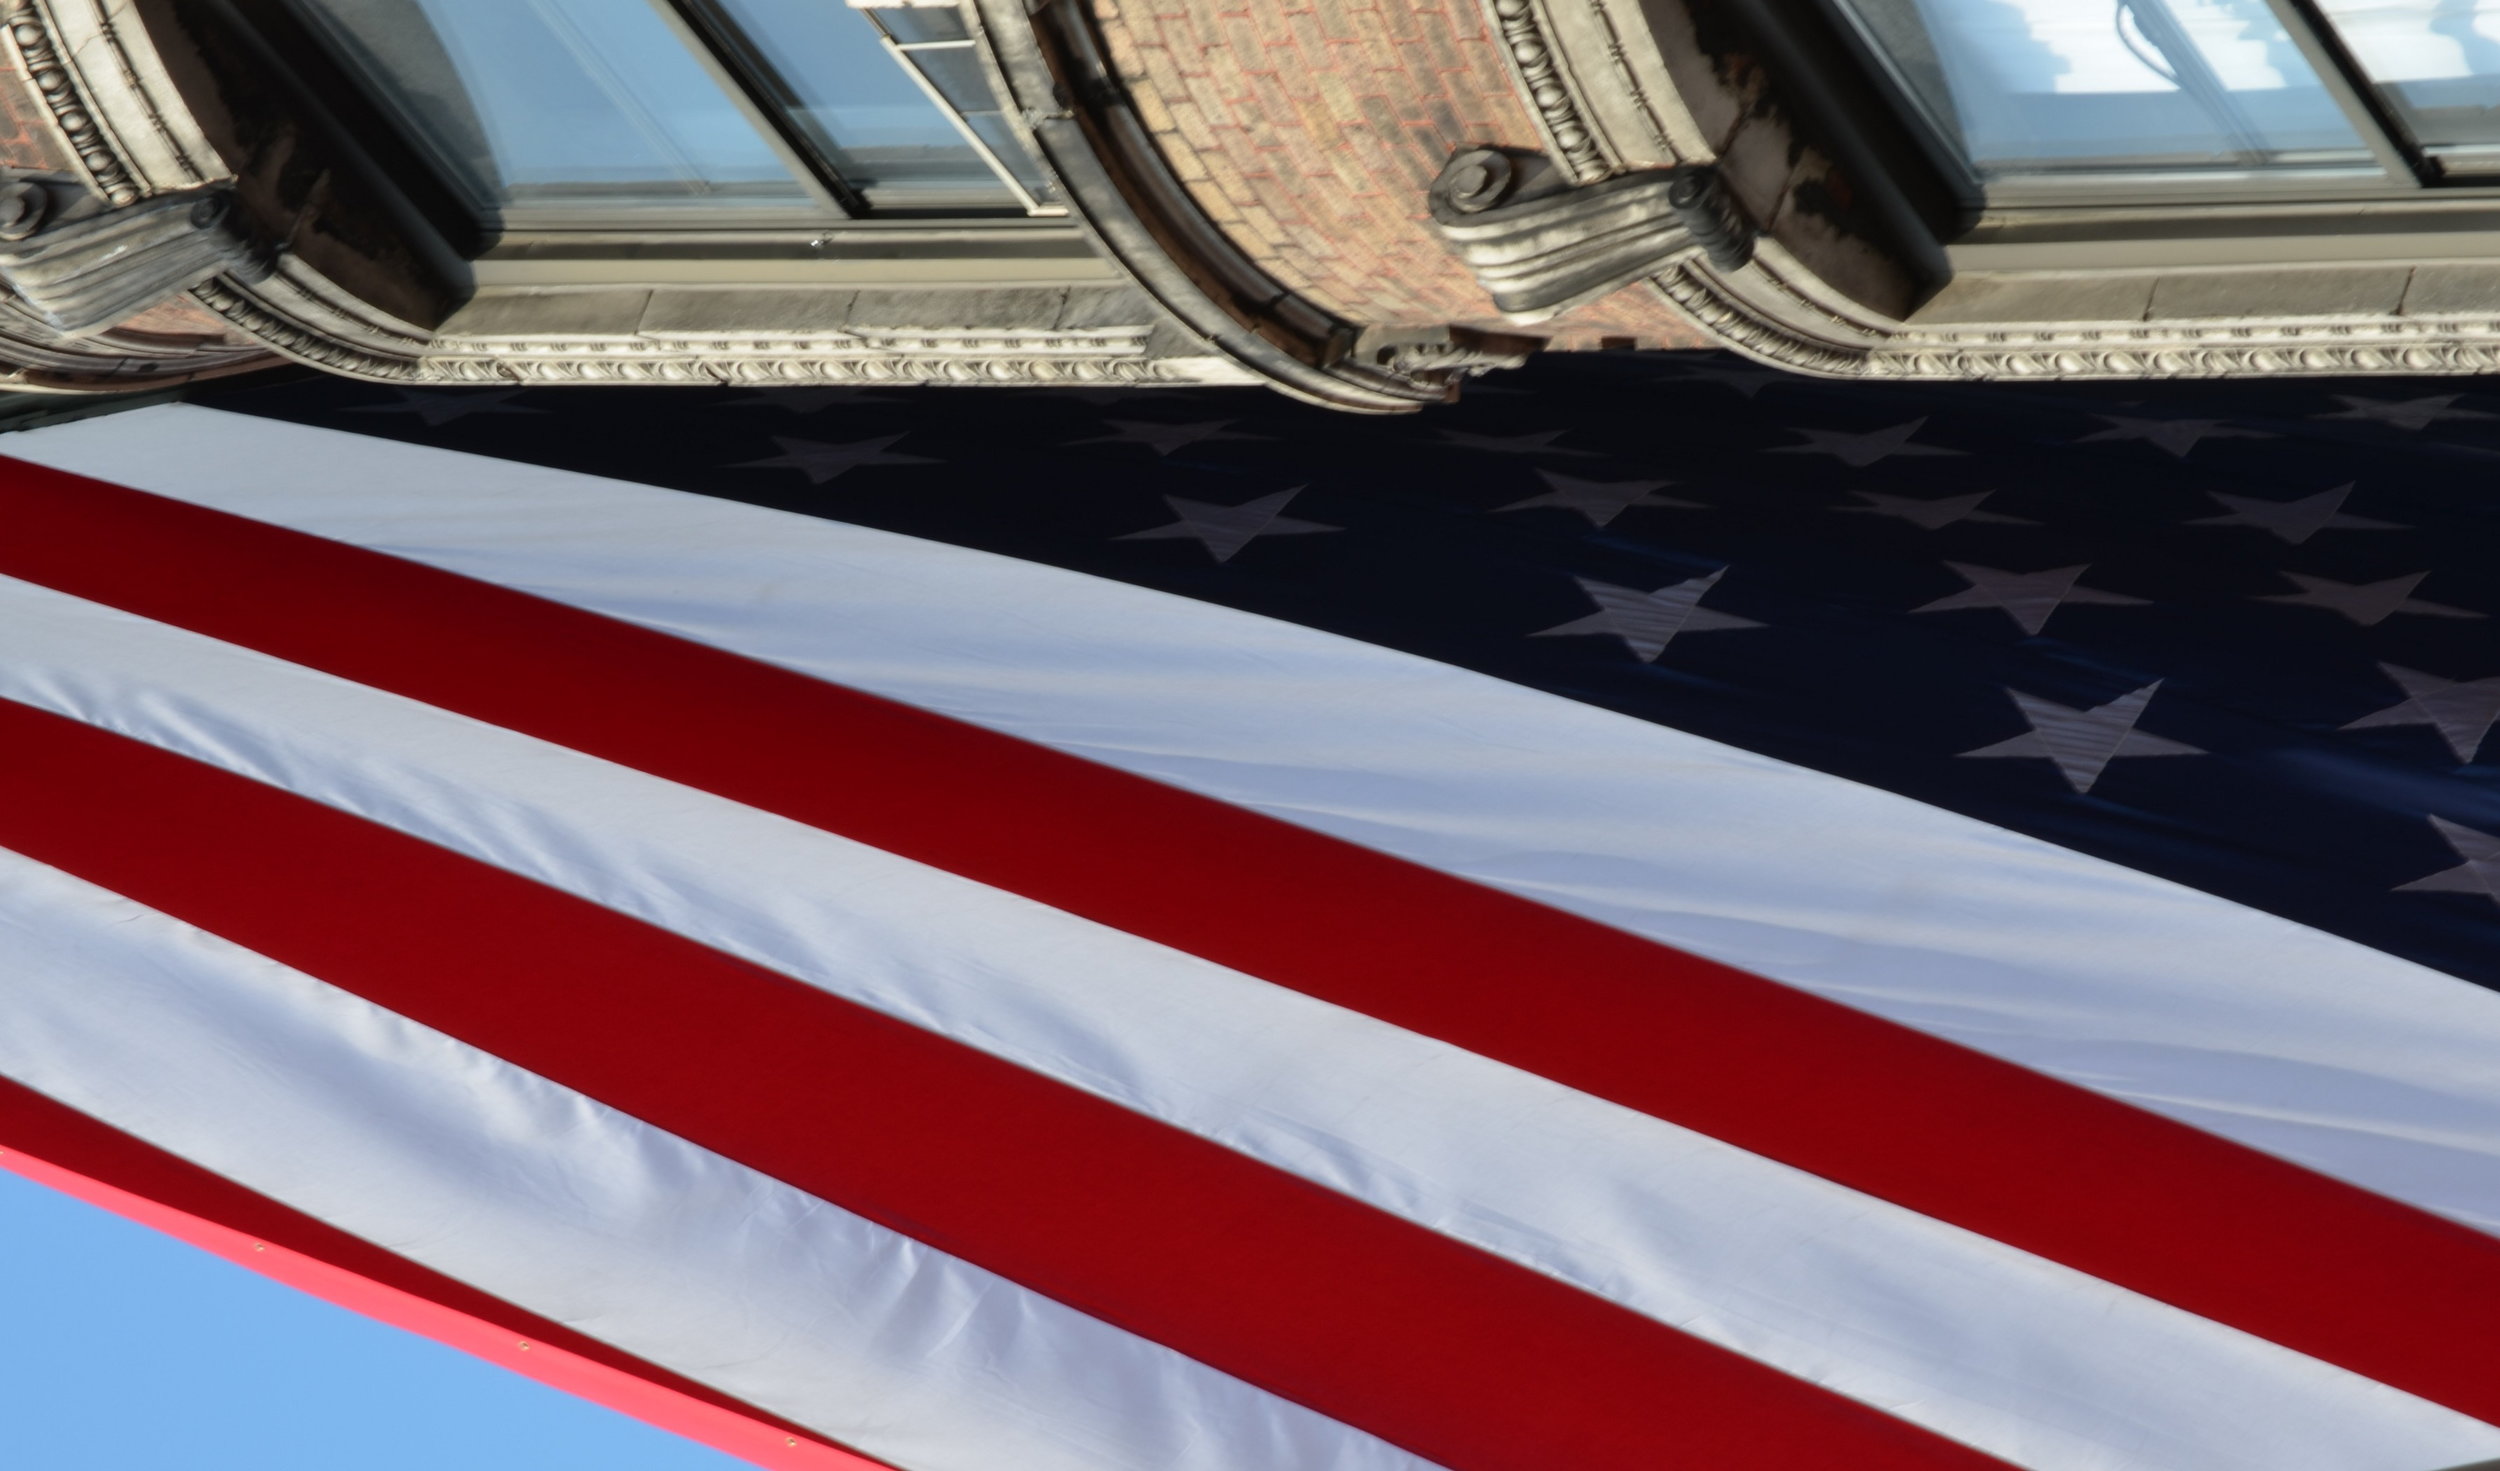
[1843,0,2370,183]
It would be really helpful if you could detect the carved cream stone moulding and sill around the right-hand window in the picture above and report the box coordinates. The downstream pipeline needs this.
[1483,0,2500,378]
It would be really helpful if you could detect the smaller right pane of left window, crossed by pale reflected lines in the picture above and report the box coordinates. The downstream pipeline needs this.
[715,0,1023,210]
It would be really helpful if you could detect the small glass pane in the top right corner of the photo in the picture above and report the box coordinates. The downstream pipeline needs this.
[2320,0,2500,173]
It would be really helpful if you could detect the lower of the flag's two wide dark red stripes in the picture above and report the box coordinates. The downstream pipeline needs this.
[0,700,2000,1471]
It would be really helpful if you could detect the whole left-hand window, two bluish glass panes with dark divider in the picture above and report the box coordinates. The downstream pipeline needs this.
[288,0,1065,233]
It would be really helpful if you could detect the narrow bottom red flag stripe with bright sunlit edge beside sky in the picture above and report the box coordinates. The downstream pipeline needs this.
[0,1078,883,1471]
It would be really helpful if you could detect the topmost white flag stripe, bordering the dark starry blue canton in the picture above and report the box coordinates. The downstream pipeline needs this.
[10,405,2500,1231]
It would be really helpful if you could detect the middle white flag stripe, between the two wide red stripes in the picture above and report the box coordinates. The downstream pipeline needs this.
[0,578,2500,1471]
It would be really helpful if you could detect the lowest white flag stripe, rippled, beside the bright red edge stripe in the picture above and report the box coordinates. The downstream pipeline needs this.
[0,851,1430,1471]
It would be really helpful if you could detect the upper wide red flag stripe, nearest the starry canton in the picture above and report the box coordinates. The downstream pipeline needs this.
[0,465,2500,1423]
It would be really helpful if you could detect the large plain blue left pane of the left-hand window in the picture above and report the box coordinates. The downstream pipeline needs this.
[295,0,815,218]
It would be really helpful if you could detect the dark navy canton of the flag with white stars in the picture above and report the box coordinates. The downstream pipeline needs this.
[238,358,2500,986]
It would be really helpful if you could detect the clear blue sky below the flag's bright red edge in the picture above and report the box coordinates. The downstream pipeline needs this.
[0,1173,753,1471]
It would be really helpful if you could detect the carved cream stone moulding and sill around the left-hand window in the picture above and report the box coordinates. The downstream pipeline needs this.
[0,0,1255,388]
